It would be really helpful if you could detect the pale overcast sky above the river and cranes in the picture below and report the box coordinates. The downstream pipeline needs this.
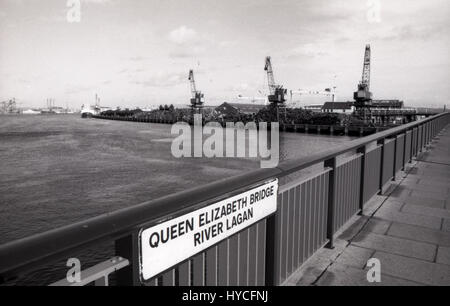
[0,0,450,107]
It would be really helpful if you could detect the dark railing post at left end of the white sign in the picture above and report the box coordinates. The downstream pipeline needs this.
[115,233,140,286]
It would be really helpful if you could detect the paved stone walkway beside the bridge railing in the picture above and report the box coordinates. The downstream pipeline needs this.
[285,126,450,285]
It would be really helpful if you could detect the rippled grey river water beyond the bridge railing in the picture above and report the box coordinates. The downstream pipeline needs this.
[0,115,351,284]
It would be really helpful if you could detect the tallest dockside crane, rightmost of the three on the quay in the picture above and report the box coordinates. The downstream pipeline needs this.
[353,45,372,122]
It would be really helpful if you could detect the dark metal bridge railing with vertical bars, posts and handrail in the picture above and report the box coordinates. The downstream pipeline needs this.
[0,113,450,285]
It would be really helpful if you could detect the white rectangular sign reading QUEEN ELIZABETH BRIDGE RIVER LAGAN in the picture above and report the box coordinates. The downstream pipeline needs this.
[139,180,278,280]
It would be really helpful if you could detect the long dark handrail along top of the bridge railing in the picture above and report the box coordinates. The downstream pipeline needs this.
[0,113,449,278]
